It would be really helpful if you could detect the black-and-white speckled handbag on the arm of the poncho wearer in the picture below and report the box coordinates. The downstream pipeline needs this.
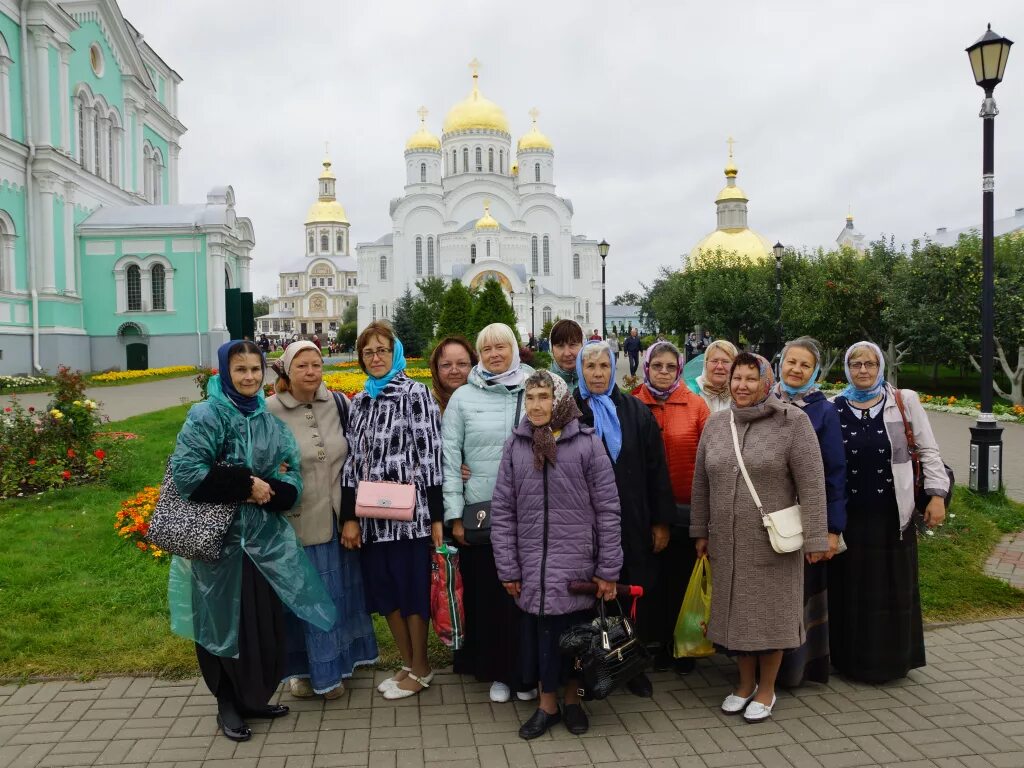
[145,459,239,562]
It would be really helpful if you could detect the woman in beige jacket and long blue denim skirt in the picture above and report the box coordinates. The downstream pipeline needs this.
[266,341,377,698]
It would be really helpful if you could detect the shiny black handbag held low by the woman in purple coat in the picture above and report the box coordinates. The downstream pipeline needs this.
[558,599,650,701]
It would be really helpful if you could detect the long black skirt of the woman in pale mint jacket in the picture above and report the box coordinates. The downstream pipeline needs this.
[454,544,536,691]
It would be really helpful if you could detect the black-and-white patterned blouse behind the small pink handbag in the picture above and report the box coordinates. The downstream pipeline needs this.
[341,373,442,542]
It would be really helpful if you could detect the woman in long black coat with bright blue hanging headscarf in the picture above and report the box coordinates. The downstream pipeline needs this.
[573,341,676,696]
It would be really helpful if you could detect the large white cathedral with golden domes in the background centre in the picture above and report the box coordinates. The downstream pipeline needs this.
[356,62,601,338]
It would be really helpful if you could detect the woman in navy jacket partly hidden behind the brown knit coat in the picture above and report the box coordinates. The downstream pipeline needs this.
[773,336,846,688]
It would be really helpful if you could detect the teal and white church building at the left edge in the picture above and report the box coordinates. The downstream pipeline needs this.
[0,0,255,374]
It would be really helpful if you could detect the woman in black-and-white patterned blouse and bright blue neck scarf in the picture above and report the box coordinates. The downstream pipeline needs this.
[341,321,444,699]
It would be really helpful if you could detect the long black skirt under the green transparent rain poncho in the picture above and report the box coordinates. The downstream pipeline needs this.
[196,555,285,712]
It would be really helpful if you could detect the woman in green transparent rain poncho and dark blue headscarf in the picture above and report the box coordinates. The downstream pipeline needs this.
[168,341,337,741]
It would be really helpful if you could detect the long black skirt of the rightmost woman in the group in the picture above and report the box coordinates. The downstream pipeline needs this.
[828,498,926,683]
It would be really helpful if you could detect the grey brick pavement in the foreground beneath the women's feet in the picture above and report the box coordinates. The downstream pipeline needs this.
[0,618,1024,768]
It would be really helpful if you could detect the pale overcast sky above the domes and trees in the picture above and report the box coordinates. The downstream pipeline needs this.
[120,0,1024,300]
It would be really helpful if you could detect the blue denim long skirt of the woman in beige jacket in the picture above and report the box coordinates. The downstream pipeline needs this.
[285,529,378,693]
